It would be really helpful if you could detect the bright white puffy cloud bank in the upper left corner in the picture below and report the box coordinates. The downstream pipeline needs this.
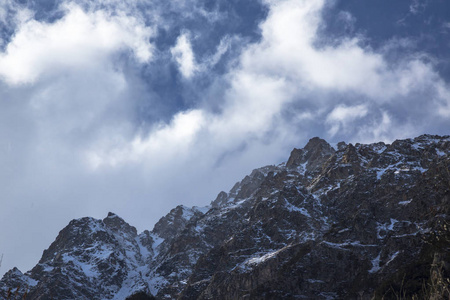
[0,4,152,84]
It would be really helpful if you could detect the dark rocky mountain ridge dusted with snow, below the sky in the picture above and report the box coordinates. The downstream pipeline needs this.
[0,135,450,299]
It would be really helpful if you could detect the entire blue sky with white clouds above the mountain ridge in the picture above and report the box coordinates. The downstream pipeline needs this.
[0,0,450,273]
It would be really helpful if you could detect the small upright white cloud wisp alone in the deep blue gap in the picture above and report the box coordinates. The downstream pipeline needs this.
[170,32,197,78]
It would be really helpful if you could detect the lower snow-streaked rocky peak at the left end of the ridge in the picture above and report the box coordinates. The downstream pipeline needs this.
[0,213,154,300]
